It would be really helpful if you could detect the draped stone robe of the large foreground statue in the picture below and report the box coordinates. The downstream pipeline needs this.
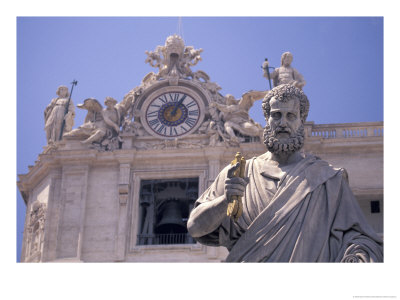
[195,153,383,262]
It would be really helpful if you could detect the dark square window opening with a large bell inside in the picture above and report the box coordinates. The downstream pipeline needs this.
[137,178,199,245]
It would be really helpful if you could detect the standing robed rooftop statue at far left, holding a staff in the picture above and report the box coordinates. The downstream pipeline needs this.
[44,85,75,144]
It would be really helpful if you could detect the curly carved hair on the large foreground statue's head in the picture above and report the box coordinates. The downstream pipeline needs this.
[262,84,310,122]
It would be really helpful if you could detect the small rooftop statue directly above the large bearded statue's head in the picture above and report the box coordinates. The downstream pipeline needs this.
[271,52,306,89]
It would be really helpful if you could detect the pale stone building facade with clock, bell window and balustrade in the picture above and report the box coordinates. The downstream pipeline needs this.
[18,36,383,262]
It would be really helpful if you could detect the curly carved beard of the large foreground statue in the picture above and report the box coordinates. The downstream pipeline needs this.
[264,124,304,155]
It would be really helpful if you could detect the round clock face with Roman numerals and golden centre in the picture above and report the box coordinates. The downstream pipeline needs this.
[145,91,200,138]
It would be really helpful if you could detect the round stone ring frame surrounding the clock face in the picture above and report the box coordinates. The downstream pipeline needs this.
[140,85,208,140]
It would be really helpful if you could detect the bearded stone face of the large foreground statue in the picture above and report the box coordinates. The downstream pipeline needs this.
[264,97,304,154]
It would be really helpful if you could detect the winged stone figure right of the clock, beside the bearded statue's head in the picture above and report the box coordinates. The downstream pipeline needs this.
[210,91,267,142]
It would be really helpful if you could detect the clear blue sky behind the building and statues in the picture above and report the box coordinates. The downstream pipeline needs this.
[17,17,383,257]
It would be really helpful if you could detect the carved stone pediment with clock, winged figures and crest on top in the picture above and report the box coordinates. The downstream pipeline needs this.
[49,35,266,151]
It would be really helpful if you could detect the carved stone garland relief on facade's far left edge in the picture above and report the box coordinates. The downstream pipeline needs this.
[26,202,47,257]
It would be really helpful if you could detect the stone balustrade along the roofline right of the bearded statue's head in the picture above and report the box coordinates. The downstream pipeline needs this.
[304,122,383,139]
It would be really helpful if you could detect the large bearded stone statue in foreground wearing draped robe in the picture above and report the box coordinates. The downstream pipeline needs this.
[188,84,383,262]
